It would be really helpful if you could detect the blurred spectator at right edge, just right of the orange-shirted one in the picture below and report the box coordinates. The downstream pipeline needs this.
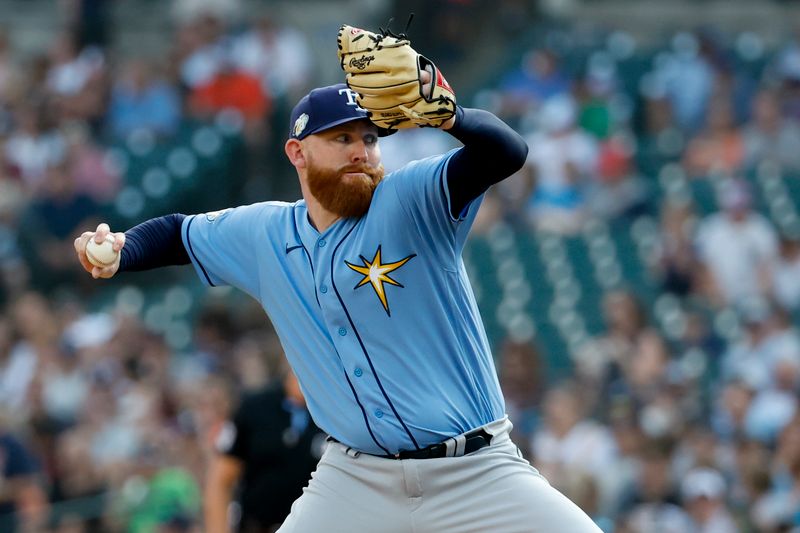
[743,89,800,172]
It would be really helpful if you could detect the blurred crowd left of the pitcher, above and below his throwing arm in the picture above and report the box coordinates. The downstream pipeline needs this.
[0,1,314,532]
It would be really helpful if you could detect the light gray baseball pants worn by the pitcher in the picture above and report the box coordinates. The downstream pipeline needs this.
[278,418,600,533]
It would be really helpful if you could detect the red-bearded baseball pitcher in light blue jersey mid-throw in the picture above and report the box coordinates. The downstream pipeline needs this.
[75,22,599,533]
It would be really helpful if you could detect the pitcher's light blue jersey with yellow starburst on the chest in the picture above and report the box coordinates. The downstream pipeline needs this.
[182,152,505,455]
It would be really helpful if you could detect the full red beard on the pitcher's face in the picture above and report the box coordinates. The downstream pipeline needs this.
[307,161,383,218]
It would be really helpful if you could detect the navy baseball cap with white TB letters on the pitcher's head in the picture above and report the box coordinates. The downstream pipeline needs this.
[289,83,394,139]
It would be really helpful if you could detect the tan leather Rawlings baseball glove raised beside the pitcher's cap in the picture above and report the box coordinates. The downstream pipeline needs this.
[337,25,456,130]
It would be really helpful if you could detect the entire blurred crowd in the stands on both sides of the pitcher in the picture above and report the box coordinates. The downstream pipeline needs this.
[0,1,800,533]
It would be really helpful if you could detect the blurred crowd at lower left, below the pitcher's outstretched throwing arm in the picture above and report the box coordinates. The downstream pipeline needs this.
[0,291,290,532]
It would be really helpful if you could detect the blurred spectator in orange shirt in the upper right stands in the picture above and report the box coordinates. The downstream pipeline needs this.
[683,96,745,178]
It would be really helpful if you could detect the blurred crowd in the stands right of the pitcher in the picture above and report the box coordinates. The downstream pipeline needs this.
[484,23,800,533]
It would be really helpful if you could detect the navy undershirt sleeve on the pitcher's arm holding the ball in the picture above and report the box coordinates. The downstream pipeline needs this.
[119,213,190,272]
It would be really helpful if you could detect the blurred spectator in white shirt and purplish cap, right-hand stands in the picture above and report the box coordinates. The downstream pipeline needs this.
[695,180,778,305]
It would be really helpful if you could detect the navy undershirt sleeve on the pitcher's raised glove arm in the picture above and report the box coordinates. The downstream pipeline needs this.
[440,106,528,218]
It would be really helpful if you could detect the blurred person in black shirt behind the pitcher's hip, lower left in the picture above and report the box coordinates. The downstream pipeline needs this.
[205,369,325,533]
